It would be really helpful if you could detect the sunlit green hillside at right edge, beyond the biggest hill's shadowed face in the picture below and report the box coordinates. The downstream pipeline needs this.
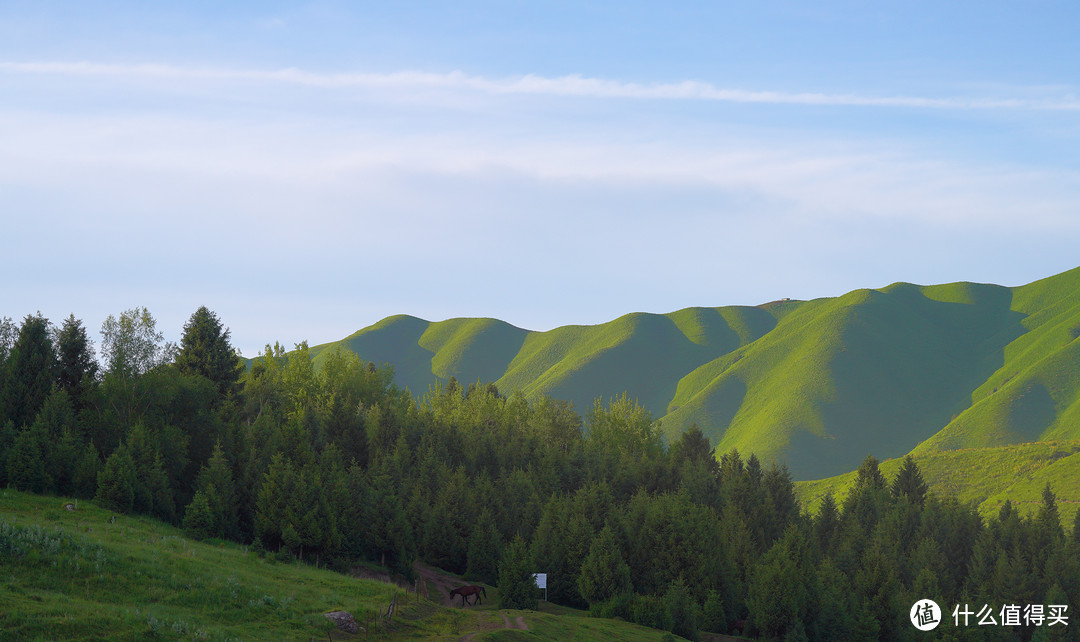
[918,264,1080,452]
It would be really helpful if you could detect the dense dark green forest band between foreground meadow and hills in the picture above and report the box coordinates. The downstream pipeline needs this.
[0,308,1080,640]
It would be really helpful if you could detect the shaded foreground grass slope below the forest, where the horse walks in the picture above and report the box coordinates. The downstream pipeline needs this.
[0,490,662,641]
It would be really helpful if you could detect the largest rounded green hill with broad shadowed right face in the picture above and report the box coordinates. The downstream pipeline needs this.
[664,283,1024,479]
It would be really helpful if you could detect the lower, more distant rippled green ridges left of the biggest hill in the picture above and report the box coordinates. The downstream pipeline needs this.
[311,307,775,417]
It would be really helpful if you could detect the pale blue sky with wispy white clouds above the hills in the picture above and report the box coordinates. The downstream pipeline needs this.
[0,0,1080,357]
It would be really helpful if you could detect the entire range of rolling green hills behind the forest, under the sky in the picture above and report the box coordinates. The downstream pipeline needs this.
[312,262,1080,479]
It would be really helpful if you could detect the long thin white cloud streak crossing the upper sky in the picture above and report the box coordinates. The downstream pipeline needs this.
[0,62,1080,111]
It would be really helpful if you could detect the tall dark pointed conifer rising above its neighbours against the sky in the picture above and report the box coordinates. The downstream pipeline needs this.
[176,306,242,397]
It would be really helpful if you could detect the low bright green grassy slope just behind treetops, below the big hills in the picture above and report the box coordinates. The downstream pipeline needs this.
[795,440,1080,529]
